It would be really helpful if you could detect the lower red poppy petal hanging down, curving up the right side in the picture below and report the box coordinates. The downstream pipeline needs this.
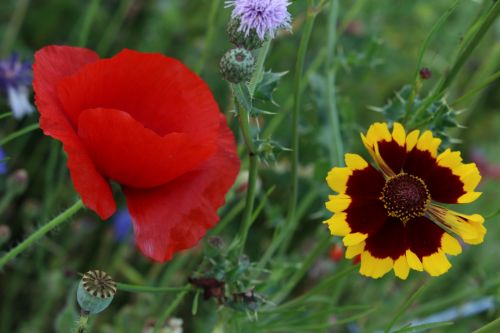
[123,116,240,261]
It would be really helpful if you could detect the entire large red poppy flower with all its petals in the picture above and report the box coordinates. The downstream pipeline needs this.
[33,46,239,261]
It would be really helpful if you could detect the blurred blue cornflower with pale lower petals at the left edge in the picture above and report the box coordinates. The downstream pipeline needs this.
[0,54,35,119]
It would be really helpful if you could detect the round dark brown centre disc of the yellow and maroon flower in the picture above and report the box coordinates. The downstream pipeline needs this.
[380,173,431,223]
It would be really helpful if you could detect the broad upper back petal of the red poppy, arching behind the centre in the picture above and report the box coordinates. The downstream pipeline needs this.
[58,50,219,142]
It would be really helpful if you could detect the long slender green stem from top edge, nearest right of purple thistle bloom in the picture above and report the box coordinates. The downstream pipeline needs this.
[283,0,317,250]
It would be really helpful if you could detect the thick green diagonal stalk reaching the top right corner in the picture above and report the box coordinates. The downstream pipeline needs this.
[409,1,500,127]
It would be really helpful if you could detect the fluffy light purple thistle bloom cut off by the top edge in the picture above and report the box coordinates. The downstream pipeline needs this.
[226,0,292,39]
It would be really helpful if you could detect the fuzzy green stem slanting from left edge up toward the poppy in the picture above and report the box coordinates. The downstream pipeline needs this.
[0,199,84,269]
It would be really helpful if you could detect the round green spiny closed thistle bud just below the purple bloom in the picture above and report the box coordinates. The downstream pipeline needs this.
[219,48,255,83]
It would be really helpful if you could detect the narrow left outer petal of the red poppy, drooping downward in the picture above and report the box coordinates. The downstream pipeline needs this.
[33,46,116,219]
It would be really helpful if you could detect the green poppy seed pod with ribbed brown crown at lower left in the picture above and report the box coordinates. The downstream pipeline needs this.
[76,270,116,314]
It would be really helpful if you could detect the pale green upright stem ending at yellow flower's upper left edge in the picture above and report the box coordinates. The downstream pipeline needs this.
[325,0,344,165]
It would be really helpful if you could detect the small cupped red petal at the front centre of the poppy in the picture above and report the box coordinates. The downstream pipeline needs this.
[78,108,216,189]
